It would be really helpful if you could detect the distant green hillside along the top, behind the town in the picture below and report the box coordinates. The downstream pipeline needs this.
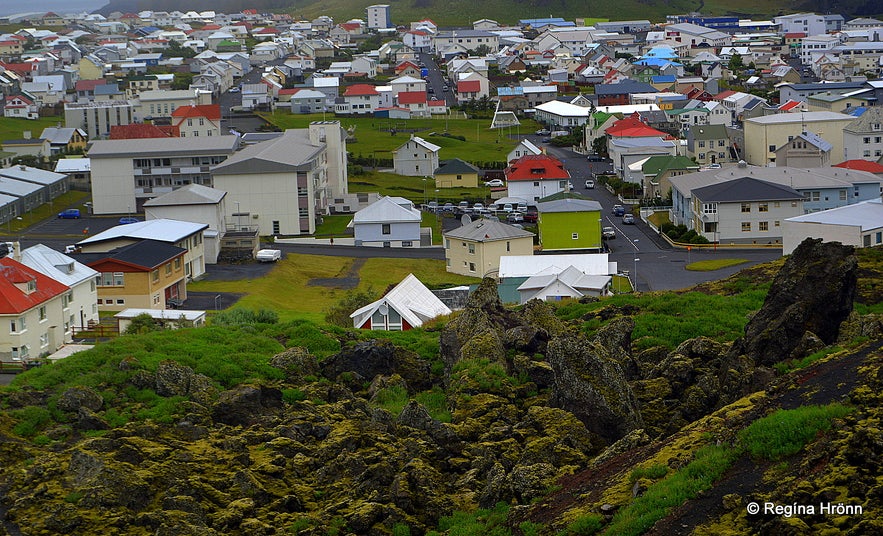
[100,0,883,26]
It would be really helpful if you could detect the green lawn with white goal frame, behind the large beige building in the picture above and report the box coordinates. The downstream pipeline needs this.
[259,111,539,162]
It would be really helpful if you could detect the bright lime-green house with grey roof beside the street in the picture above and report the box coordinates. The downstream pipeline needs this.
[537,192,602,251]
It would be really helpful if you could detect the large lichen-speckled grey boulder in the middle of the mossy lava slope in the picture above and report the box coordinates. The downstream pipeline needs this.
[547,337,643,442]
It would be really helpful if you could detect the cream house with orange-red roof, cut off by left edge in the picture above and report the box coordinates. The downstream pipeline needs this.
[0,257,70,365]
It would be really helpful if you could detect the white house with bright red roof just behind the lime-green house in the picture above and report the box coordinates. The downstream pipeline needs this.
[504,154,570,201]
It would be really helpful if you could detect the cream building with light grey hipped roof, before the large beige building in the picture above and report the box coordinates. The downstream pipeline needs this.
[143,184,228,264]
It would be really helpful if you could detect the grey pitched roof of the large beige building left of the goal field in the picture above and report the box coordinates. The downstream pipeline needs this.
[212,129,324,175]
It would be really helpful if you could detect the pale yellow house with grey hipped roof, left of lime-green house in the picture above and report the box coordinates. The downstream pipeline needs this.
[444,219,535,277]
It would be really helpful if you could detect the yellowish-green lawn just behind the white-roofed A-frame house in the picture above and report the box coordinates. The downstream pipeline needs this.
[187,254,479,323]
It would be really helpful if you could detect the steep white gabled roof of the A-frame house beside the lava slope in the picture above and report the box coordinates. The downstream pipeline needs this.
[350,274,451,327]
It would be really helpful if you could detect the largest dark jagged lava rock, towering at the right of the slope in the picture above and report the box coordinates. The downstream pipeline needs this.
[732,238,858,366]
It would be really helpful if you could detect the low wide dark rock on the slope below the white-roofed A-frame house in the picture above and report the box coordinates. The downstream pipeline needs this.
[321,339,431,391]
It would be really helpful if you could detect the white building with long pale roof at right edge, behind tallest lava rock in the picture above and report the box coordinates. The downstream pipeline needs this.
[782,198,883,255]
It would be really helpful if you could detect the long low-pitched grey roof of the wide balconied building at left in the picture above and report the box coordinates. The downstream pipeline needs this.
[88,136,239,159]
